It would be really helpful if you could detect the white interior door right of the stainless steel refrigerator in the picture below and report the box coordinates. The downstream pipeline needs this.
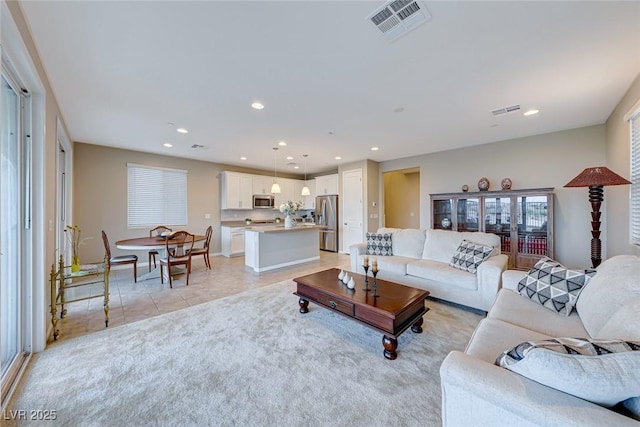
[340,169,364,253]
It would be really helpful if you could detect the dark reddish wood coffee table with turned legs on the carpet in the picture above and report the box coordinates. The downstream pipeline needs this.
[293,268,429,360]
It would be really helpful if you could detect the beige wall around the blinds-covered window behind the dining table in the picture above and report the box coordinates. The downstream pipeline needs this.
[73,143,220,262]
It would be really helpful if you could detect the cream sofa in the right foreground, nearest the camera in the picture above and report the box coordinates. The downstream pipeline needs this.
[440,255,640,427]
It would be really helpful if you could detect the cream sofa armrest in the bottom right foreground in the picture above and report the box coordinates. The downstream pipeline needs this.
[440,351,638,427]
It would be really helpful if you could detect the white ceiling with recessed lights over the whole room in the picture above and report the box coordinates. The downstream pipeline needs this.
[21,0,640,173]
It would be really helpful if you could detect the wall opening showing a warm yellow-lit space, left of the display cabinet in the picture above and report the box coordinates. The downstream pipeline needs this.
[383,167,420,228]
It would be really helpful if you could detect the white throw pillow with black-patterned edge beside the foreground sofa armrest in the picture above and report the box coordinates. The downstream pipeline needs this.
[496,338,640,406]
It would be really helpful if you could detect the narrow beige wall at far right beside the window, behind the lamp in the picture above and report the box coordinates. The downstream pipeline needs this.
[602,74,640,255]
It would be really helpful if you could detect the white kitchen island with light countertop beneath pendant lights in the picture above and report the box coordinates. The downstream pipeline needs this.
[244,224,321,273]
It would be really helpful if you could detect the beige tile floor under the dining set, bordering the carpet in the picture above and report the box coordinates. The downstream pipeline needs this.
[49,251,350,344]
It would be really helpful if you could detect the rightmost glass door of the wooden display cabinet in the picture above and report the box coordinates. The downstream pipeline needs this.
[516,196,548,255]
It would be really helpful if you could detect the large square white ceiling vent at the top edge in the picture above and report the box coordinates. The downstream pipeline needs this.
[367,0,431,41]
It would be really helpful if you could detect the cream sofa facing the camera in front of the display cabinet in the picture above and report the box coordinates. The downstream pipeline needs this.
[350,228,507,311]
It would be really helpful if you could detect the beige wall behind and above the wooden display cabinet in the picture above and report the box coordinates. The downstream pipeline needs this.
[380,125,608,267]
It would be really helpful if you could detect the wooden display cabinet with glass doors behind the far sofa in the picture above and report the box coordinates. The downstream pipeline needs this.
[430,188,553,270]
